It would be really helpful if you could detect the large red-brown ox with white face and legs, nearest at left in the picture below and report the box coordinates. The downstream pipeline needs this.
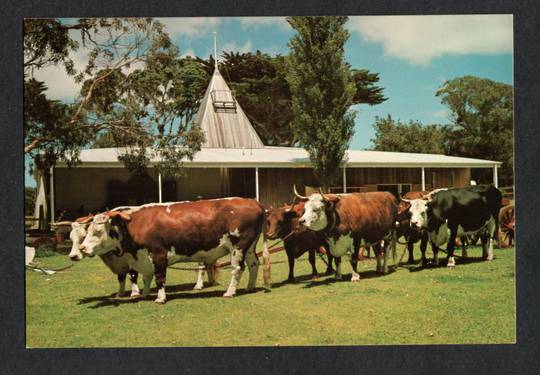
[80,198,269,303]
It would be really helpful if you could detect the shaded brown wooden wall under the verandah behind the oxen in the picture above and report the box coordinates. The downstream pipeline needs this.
[55,168,470,217]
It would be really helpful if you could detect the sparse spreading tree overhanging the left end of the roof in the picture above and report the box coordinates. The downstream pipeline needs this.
[24,18,206,176]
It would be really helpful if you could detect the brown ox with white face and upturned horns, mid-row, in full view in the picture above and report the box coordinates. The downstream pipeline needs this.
[294,188,397,281]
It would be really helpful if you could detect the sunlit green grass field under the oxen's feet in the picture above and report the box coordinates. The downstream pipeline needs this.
[26,245,516,348]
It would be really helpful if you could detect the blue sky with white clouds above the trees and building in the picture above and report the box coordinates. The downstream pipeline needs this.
[27,15,513,187]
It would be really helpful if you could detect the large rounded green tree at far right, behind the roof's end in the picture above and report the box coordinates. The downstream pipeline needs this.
[436,76,514,184]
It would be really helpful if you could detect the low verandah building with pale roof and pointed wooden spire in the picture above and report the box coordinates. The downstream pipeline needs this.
[44,67,501,221]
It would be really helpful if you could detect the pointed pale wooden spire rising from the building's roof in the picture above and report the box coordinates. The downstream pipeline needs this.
[195,69,264,149]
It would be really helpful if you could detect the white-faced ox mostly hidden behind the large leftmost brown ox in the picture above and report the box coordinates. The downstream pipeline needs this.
[65,213,216,297]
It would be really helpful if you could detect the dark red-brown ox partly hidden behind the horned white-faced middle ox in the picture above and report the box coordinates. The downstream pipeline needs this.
[266,202,341,283]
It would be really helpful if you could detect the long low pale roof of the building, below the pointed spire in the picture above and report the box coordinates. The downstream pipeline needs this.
[59,146,501,168]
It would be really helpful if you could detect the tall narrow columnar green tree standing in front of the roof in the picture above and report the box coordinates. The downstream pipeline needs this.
[286,17,356,188]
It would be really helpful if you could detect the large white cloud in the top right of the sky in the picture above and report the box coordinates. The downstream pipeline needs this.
[348,15,513,65]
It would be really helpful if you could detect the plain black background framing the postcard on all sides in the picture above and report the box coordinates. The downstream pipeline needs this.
[0,0,540,375]
